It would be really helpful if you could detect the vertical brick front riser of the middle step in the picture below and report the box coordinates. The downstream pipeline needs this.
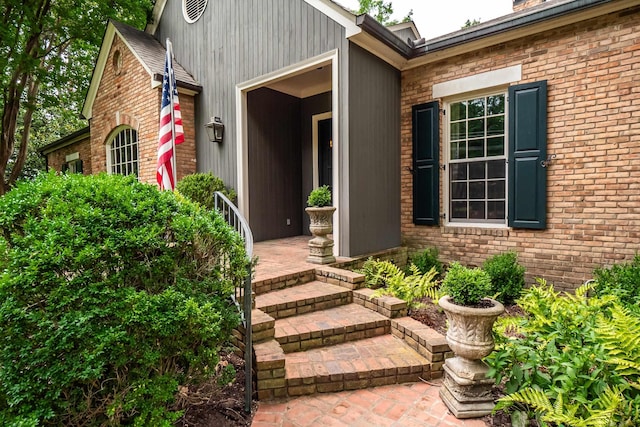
[276,322,391,353]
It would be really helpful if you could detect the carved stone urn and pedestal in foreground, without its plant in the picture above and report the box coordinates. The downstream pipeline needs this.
[438,296,504,418]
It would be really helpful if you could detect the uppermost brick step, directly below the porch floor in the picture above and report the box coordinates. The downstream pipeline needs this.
[255,280,353,319]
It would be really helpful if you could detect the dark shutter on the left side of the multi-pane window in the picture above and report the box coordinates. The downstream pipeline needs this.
[412,101,440,225]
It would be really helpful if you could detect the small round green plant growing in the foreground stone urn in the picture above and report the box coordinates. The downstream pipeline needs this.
[442,262,491,305]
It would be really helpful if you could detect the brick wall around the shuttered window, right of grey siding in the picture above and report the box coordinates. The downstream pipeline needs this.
[401,8,640,288]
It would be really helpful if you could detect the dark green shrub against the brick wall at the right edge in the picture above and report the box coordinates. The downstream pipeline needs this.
[593,254,640,309]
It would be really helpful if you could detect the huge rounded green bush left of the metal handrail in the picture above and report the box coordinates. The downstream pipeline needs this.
[0,174,246,425]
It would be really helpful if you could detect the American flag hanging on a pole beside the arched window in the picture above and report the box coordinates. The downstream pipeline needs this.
[156,39,184,190]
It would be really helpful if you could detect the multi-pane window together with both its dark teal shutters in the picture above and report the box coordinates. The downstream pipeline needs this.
[411,81,547,229]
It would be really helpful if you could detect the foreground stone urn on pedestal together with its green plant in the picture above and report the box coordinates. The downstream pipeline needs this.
[438,262,504,418]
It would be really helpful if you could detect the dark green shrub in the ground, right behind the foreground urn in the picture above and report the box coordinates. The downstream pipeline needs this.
[482,252,524,304]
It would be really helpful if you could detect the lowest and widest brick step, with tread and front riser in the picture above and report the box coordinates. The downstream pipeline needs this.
[285,334,431,396]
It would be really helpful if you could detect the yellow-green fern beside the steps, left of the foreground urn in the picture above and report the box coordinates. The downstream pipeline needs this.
[365,261,440,308]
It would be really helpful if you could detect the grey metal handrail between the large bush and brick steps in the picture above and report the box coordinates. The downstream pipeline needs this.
[214,191,253,413]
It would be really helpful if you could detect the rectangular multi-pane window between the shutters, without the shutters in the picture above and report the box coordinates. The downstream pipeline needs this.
[444,92,507,224]
